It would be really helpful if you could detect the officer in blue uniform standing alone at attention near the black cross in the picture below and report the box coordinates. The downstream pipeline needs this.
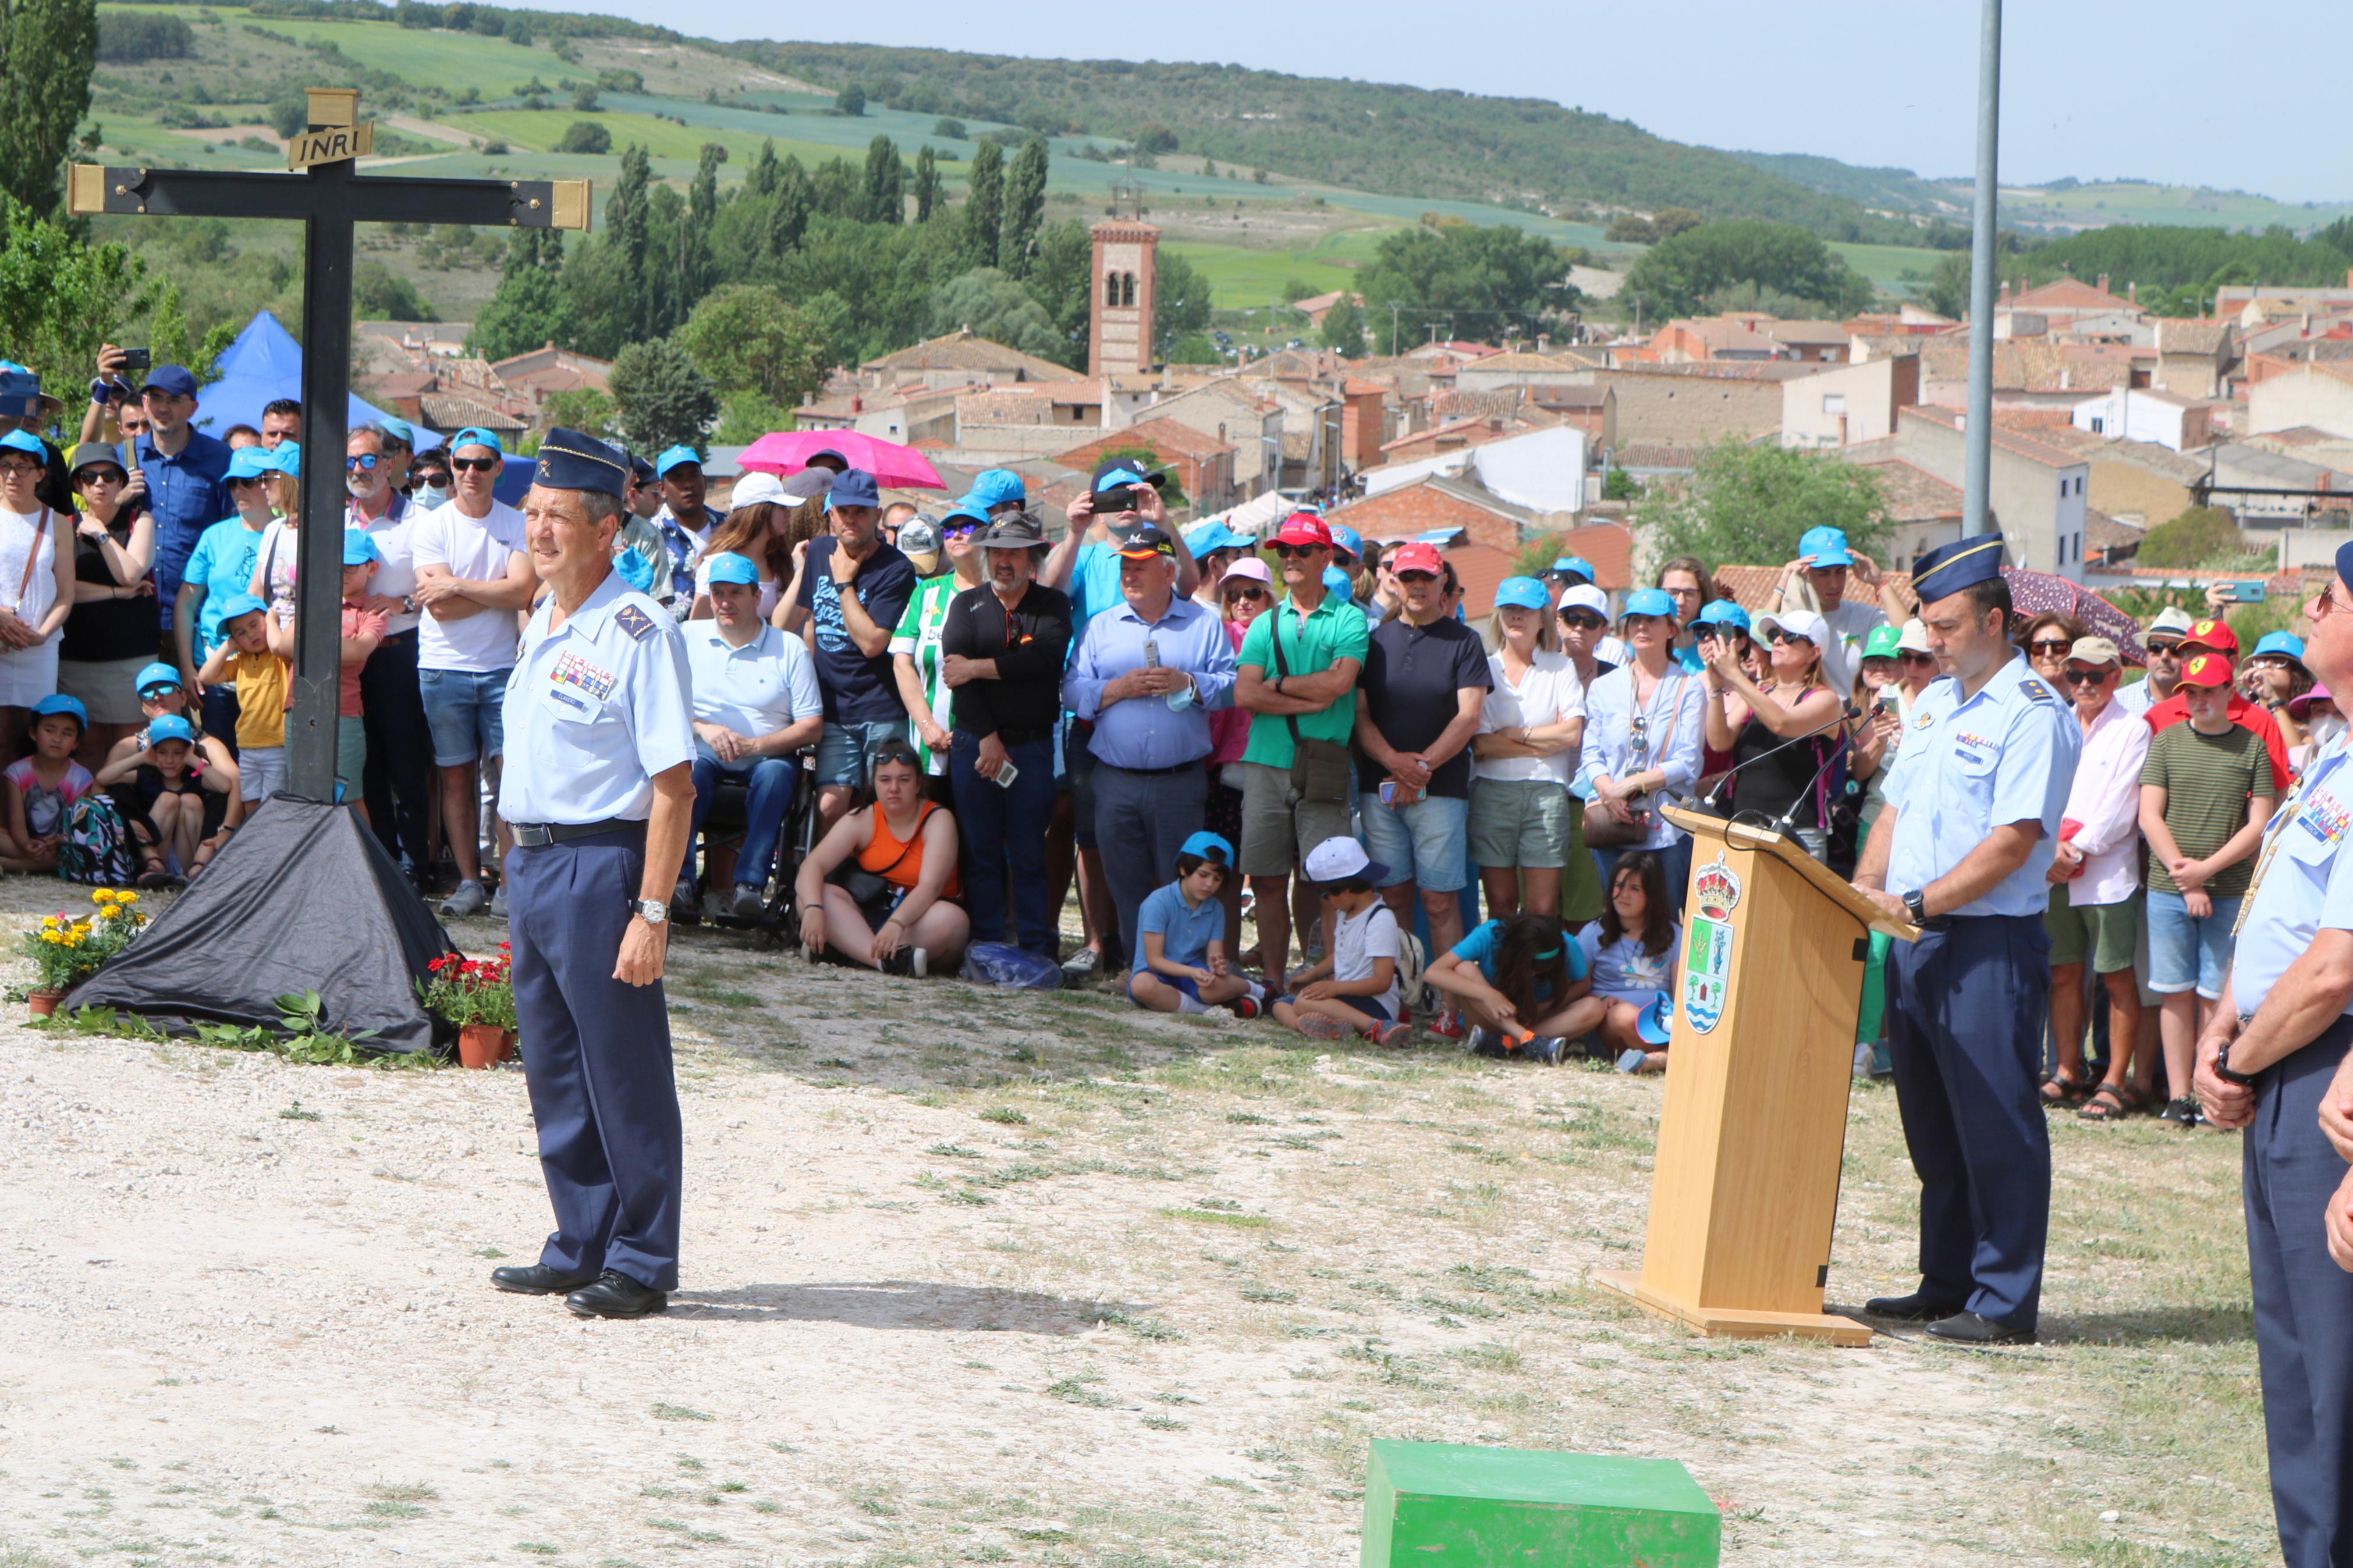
[492,430,694,1317]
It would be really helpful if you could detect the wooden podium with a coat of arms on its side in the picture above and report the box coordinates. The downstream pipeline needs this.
[1593,806,1920,1345]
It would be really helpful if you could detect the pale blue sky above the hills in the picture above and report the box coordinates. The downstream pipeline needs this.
[538,0,2353,202]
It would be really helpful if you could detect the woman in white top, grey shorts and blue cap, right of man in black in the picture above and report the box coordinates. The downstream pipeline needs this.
[1471,576,1600,924]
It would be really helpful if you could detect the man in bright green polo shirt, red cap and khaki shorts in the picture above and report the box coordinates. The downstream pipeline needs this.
[1233,513,1367,987]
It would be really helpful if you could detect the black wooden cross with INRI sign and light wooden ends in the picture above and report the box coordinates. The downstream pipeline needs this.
[66,87,588,799]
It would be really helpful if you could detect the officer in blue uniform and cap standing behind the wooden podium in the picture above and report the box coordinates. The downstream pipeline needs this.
[1854,534,2082,1345]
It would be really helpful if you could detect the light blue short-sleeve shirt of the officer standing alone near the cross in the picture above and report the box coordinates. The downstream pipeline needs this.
[499,571,694,825]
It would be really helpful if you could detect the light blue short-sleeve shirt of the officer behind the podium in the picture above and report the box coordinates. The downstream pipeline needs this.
[1882,658,2082,917]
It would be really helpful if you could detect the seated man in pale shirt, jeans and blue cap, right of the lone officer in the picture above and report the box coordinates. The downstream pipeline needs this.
[670,555,826,919]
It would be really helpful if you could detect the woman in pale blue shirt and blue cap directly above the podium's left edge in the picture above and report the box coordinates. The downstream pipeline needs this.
[1577,588,1708,910]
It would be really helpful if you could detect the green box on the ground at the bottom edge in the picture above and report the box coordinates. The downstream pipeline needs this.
[1362,1441,1722,1568]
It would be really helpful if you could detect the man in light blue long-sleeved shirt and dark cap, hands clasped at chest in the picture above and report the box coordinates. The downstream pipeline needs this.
[1061,522,1233,962]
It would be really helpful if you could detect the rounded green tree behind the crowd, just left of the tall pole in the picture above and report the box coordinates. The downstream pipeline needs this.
[1633,440,1894,567]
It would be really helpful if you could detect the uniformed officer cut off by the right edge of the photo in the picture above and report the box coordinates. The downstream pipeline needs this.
[2195,545,2353,1568]
